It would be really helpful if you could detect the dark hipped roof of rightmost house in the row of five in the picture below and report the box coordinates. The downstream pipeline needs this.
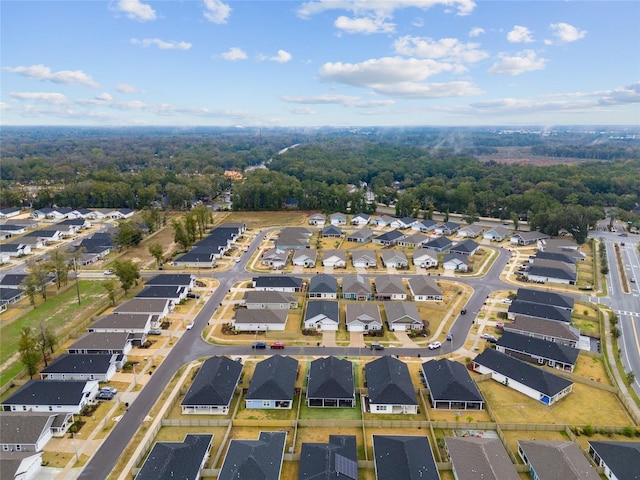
[422,358,484,402]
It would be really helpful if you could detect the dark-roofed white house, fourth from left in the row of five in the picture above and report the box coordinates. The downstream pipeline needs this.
[364,355,418,414]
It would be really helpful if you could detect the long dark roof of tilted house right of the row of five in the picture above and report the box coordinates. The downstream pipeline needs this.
[473,348,573,397]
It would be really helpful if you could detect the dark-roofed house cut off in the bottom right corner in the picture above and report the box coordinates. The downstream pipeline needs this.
[588,441,640,480]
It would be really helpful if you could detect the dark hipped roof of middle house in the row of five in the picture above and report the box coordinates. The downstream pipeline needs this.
[307,357,355,398]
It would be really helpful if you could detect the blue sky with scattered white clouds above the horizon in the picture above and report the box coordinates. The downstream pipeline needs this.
[0,0,640,126]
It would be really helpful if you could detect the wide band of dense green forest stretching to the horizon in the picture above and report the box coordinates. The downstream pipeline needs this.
[0,127,640,242]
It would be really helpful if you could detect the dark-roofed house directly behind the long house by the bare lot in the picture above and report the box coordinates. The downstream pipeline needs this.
[496,331,579,372]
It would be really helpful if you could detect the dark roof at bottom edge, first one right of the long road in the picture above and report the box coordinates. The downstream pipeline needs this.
[135,433,213,480]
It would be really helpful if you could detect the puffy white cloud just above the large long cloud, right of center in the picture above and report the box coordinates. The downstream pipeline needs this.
[393,36,489,63]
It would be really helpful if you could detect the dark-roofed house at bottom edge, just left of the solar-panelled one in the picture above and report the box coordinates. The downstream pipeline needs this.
[218,432,287,480]
